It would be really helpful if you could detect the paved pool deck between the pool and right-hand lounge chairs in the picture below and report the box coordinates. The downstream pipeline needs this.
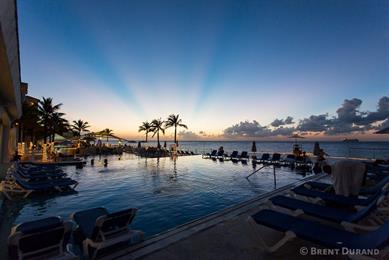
[109,175,344,260]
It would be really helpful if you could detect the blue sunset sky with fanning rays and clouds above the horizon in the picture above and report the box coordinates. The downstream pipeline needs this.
[18,0,389,139]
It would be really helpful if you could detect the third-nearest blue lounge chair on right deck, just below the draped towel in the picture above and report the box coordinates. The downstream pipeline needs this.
[291,185,380,206]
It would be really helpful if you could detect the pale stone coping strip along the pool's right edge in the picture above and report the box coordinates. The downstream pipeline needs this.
[110,174,326,259]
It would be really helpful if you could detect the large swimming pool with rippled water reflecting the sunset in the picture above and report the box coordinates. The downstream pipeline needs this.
[0,154,310,251]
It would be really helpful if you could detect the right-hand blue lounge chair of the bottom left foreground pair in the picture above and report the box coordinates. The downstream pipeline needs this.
[71,207,144,259]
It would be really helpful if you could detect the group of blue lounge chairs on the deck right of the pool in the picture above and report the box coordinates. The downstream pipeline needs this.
[248,165,389,257]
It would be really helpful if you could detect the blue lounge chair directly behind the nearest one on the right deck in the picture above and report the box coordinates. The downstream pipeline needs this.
[269,195,384,223]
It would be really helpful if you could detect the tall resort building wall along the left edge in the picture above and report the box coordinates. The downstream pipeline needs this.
[0,0,23,164]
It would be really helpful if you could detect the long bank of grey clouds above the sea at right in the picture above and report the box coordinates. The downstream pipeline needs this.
[224,96,389,137]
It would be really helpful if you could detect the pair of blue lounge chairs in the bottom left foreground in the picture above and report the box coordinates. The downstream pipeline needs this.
[8,207,144,259]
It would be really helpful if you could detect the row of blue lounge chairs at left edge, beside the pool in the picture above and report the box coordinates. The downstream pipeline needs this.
[0,162,78,200]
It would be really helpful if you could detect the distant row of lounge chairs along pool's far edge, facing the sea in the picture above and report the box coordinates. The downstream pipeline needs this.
[202,150,312,167]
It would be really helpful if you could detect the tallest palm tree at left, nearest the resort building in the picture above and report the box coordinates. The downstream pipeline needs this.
[38,97,62,143]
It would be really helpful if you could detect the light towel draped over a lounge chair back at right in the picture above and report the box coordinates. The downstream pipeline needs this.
[331,160,365,196]
